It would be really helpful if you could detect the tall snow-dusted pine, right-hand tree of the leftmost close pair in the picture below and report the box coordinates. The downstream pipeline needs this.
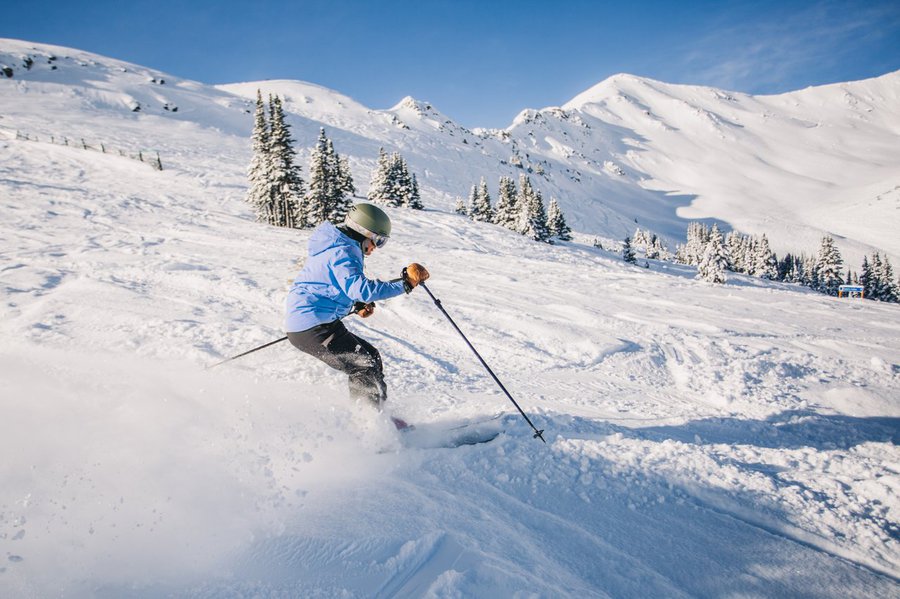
[267,96,305,228]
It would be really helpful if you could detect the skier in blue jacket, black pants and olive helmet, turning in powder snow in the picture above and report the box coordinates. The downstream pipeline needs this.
[284,204,429,428]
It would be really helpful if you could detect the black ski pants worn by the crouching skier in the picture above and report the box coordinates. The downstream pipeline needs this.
[287,320,387,408]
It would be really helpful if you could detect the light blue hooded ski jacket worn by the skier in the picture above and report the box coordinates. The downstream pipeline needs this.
[284,222,403,333]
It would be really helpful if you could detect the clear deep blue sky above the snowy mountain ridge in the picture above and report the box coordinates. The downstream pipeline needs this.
[7,0,900,128]
